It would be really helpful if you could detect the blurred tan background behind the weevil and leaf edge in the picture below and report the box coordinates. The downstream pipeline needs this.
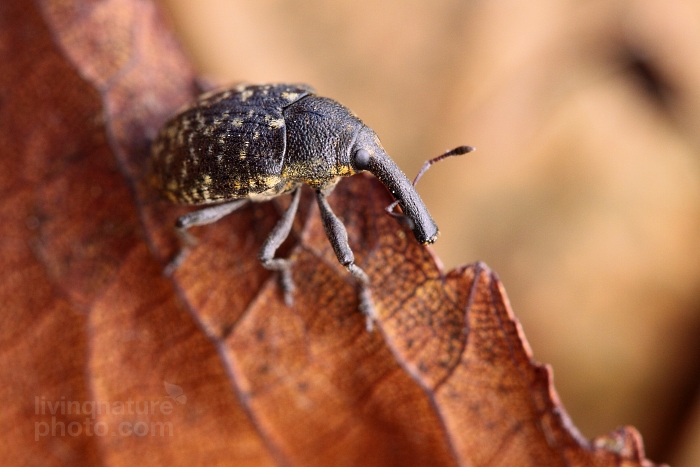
[157,0,700,466]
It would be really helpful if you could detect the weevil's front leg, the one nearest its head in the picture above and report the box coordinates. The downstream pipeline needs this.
[316,191,376,331]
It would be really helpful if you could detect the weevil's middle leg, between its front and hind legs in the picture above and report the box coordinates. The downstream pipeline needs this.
[258,186,301,306]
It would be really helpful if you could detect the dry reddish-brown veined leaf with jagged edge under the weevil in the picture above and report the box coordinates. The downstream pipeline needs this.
[0,0,668,466]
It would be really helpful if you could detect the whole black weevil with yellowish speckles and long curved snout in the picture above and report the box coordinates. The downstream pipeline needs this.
[151,84,472,329]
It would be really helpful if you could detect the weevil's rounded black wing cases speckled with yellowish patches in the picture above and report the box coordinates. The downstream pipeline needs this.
[152,84,314,204]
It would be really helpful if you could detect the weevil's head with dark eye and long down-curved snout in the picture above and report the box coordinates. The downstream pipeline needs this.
[350,126,438,244]
